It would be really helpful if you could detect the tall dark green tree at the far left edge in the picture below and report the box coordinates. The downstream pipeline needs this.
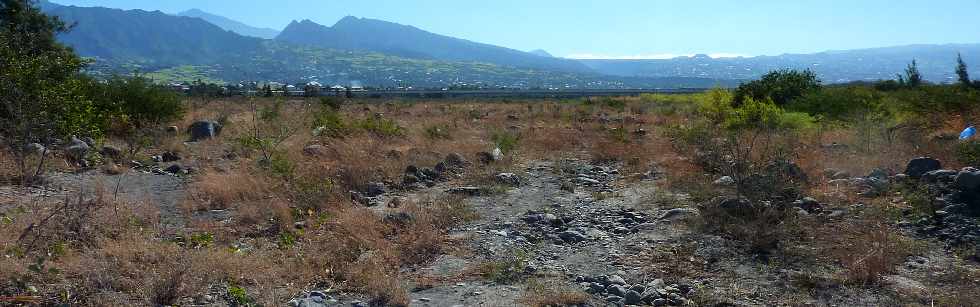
[0,0,101,183]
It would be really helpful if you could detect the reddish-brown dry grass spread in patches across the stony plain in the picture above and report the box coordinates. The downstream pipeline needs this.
[0,98,976,306]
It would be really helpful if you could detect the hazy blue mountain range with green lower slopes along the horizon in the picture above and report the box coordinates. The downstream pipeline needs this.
[34,1,980,88]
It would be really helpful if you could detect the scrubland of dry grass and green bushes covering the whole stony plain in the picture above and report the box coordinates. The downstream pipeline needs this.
[0,1,980,306]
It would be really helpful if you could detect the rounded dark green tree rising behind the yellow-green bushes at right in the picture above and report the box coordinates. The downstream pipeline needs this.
[734,70,821,106]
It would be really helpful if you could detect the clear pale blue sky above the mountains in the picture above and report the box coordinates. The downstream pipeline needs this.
[52,0,980,58]
